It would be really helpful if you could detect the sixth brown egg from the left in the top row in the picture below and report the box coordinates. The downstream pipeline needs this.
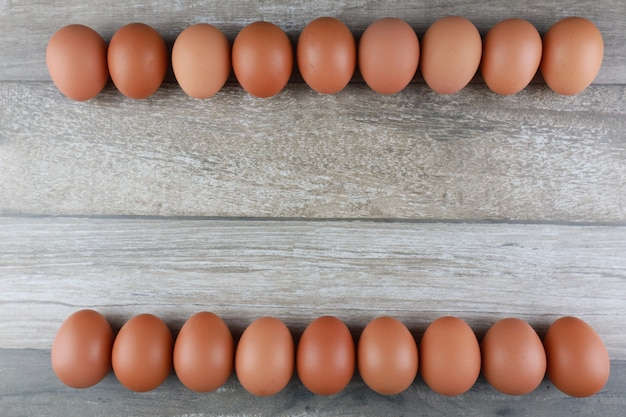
[358,17,420,94]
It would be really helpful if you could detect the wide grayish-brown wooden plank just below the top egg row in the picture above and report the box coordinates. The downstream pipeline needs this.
[0,82,626,222]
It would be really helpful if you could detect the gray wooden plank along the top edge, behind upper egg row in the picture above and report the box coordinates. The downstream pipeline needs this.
[0,0,626,84]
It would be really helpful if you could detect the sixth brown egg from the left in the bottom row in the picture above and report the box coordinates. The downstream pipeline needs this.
[357,316,418,395]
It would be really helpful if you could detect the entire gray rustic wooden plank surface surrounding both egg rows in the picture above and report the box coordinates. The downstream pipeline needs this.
[0,0,626,416]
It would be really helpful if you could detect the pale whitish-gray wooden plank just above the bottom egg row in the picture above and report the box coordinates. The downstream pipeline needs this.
[0,217,626,360]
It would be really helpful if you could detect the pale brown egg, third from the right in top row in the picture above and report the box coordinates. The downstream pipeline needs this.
[421,16,482,94]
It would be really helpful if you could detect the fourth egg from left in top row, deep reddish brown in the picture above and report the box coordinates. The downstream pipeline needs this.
[233,22,293,98]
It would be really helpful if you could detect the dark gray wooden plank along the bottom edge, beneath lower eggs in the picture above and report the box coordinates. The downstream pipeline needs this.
[0,349,626,417]
